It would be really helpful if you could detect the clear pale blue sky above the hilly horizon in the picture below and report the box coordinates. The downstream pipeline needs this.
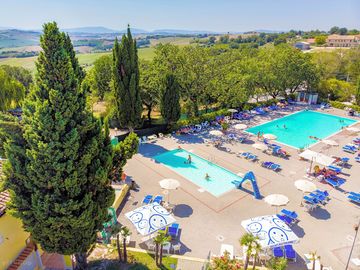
[0,0,360,32]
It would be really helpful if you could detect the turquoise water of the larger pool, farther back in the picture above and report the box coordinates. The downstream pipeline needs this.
[246,111,356,148]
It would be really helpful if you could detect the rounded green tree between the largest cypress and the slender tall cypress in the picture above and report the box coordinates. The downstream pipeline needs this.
[91,55,112,100]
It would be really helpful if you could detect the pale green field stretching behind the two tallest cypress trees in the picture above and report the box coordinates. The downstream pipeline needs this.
[0,47,154,71]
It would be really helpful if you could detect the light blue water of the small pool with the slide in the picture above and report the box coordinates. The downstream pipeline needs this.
[154,149,242,196]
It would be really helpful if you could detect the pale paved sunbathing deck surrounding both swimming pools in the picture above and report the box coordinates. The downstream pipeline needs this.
[119,107,360,270]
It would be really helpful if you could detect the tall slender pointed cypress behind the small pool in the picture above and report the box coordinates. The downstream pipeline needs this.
[113,26,142,131]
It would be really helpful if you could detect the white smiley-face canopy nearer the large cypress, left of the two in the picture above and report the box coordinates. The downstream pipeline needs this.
[125,203,175,235]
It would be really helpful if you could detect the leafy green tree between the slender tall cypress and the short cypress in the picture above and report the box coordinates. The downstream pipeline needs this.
[140,61,162,123]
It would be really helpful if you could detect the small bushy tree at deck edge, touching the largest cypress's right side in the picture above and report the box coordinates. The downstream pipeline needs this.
[110,132,139,182]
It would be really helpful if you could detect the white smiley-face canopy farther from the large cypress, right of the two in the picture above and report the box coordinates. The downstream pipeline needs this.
[241,215,299,248]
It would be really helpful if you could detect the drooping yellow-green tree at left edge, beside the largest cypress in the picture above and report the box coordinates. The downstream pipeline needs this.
[0,69,25,112]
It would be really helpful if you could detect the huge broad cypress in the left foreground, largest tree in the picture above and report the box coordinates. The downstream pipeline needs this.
[5,23,114,269]
